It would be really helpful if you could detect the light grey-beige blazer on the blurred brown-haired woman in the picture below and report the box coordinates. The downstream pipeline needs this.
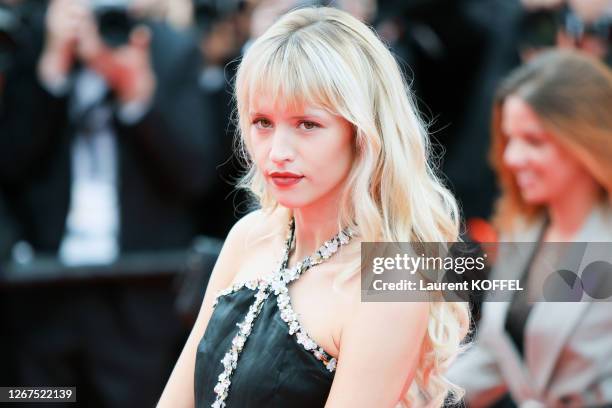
[448,207,612,408]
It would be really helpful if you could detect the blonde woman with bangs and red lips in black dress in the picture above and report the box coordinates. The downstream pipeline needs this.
[159,8,469,408]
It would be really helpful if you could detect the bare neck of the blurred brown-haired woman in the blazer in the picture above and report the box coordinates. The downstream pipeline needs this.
[545,179,601,242]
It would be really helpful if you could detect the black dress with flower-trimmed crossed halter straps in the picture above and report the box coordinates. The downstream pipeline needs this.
[194,220,350,408]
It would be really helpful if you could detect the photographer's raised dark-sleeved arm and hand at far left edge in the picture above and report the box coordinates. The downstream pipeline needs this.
[0,0,72,185]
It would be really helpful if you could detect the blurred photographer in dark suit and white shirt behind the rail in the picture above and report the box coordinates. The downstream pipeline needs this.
[0,0,220,406]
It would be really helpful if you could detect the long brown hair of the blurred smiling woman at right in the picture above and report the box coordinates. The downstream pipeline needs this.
[489,50,612,232]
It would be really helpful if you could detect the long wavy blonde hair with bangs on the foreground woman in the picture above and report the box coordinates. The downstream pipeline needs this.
[236,7,469,407]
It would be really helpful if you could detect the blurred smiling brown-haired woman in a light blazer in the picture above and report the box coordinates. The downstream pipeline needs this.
[449,50,612,408]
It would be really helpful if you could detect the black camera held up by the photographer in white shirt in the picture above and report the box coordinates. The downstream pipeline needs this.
[91,0,137,48]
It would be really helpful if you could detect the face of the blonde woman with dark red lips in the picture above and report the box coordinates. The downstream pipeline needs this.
[248,96,354,208]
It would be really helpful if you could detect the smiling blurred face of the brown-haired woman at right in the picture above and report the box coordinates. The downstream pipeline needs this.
[502,96,592,205]
